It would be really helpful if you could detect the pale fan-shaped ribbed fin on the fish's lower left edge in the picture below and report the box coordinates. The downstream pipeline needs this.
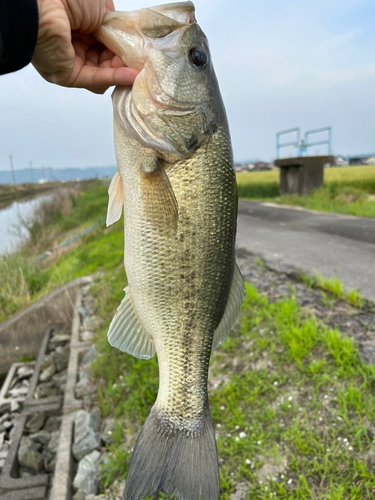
[107,287,155,359]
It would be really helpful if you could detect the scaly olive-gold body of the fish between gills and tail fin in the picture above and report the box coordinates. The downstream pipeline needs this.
[122,125,237,429]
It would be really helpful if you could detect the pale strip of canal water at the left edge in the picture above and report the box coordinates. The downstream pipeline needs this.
[0,193,51,255]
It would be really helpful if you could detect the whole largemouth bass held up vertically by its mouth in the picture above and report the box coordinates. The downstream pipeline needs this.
[95,1,244,500]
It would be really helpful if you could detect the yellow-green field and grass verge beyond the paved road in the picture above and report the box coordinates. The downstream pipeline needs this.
[237,166,375,217]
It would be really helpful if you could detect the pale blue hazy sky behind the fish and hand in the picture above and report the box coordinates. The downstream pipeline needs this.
[0,0,375,170]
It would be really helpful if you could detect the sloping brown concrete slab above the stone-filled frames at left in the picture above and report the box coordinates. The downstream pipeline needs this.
[0,277,92,374]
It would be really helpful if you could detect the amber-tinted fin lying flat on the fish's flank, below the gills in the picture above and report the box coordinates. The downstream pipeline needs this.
[141,162,178,231]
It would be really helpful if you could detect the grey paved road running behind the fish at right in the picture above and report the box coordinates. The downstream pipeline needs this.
[237,201,375,299]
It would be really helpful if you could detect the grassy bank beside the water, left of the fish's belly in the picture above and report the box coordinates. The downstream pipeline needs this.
[0,181,108,321]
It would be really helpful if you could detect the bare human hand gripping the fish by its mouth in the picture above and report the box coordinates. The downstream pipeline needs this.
[32,0,138,94]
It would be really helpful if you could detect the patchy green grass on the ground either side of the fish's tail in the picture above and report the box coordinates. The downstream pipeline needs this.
[92,280,375,500]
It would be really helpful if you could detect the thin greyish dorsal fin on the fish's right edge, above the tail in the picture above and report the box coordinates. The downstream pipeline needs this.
[212,262,245,350]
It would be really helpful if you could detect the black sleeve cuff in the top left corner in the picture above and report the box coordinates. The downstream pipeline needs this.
[0,0,38,75]
